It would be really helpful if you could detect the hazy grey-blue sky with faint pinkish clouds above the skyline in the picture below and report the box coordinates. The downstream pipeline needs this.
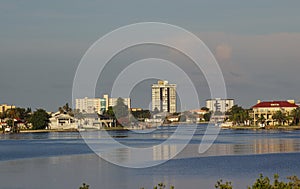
[0,0,300,111]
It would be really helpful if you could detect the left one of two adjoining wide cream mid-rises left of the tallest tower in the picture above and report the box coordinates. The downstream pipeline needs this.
[75,97,106,114]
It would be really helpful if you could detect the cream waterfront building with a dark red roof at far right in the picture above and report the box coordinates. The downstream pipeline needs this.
[252,100,298,125]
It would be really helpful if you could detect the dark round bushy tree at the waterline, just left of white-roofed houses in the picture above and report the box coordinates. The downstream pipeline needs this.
[30,109,50,129]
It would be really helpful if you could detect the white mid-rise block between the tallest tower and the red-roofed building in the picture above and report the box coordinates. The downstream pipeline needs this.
[206,98,234,113]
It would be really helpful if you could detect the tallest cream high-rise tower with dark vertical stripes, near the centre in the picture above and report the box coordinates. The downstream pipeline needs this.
[152,80,176,113]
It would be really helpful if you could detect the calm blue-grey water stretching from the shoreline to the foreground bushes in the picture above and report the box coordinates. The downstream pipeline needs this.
[0,125,300,189]
